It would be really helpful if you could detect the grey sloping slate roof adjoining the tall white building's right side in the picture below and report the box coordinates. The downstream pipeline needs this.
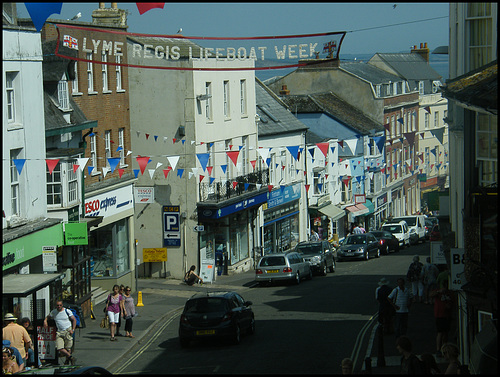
[255,77,308,136]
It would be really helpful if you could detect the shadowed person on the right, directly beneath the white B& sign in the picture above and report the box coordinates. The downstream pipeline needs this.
[430,278,454,357]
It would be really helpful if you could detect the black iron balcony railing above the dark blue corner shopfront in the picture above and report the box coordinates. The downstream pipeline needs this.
[199,170,269,203]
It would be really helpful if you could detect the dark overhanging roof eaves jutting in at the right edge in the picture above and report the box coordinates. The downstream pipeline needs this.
[443,60,498,114]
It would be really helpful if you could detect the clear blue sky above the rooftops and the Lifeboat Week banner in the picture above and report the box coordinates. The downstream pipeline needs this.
[17,2,449,54]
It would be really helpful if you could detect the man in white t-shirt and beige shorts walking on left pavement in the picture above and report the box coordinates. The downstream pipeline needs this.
[43,300,76,365]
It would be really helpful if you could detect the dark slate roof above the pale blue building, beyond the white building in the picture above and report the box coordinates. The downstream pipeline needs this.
[282,92,384,135]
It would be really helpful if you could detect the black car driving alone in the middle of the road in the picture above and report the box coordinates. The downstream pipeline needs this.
[179,291,255,347]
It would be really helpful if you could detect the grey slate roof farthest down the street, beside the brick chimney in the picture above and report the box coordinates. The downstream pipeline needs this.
[368,53,442,80]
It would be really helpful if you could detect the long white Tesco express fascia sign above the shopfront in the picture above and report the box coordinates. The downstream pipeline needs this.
[85,186,134,217]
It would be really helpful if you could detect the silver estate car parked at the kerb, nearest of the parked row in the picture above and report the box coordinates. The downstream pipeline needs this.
[255,251,312,285]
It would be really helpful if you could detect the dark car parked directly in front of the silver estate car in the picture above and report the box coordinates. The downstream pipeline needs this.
[295,241,336,276]
